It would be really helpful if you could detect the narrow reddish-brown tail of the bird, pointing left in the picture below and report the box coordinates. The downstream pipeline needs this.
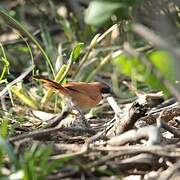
[33,75,67,94]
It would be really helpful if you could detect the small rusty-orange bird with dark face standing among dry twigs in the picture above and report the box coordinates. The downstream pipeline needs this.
[33,75,112,126]
